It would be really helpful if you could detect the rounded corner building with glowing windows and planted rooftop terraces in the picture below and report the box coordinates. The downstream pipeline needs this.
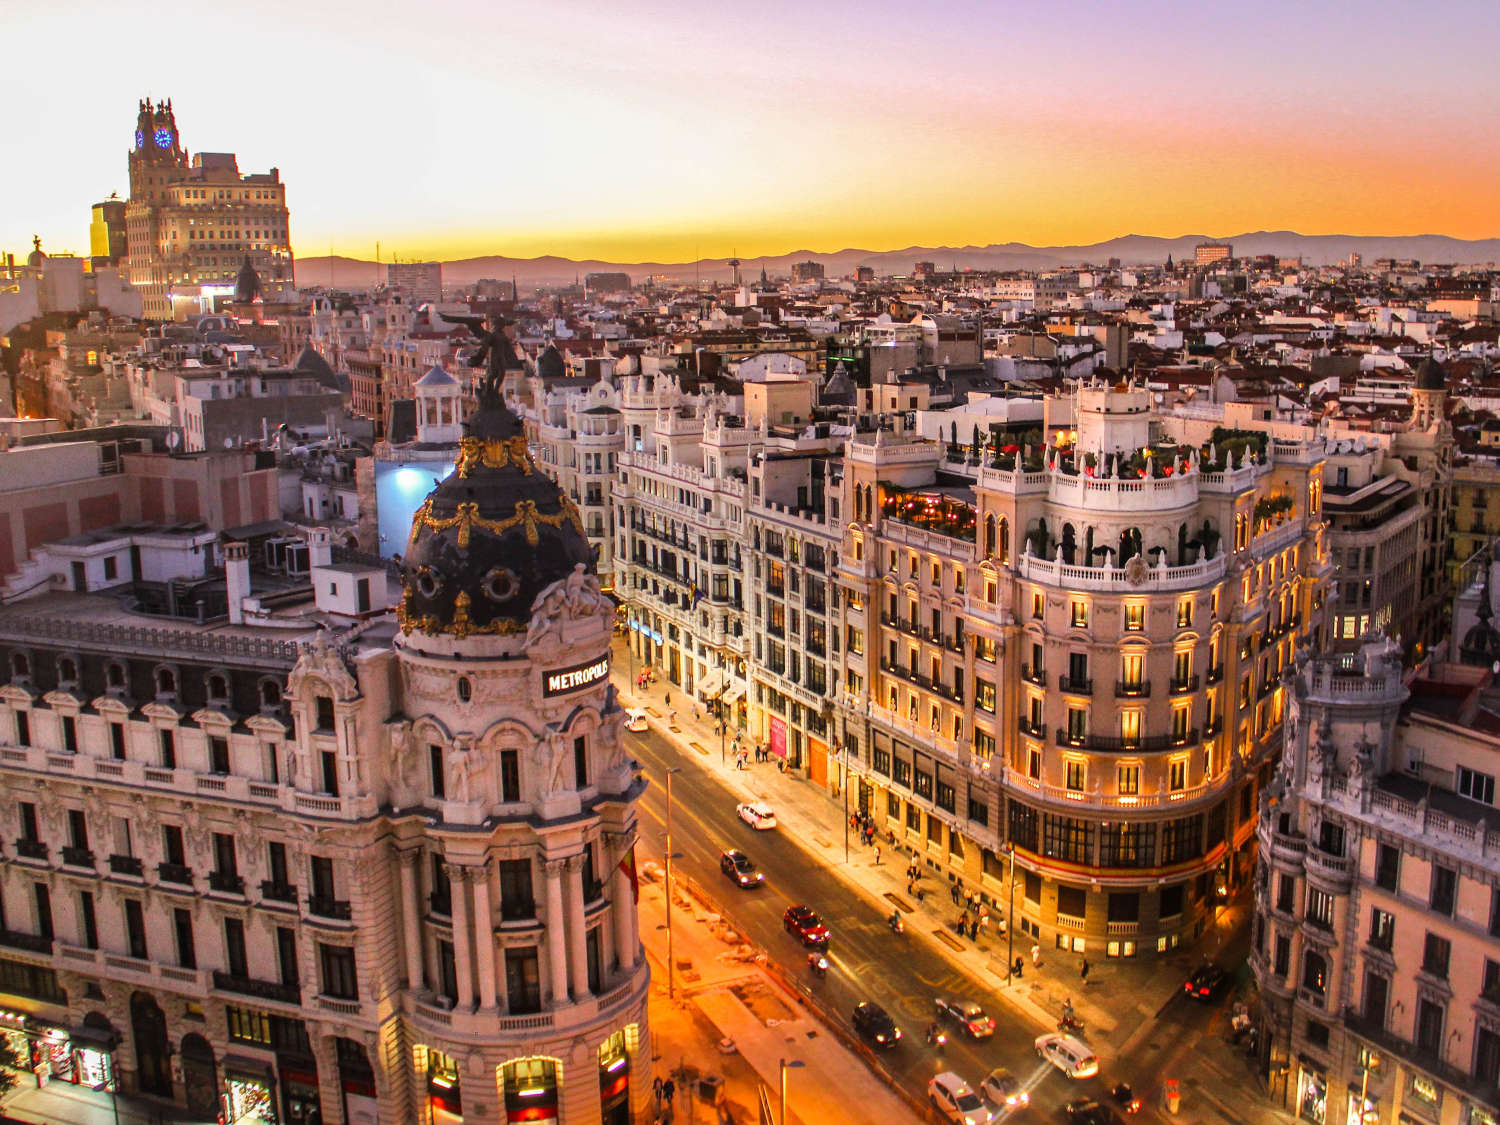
[839,384,1332,957]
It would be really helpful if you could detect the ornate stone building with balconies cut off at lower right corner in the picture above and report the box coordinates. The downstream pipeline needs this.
[1250,635,1500,1125]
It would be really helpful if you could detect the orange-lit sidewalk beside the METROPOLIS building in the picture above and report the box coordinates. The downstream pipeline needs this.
[641,867,920,1125]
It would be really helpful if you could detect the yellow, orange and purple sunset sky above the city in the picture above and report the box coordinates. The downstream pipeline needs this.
[0,0,1500,263]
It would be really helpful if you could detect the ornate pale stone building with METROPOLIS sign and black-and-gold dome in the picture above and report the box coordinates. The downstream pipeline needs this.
[0,396,651,1125]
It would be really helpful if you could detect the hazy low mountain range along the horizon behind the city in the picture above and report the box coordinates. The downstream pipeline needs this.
[297,231,1500,288]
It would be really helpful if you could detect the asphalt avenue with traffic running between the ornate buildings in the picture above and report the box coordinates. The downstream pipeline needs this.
[627,731,1215,1125]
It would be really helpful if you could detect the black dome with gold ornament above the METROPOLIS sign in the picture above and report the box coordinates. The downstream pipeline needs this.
[399,393,594,636]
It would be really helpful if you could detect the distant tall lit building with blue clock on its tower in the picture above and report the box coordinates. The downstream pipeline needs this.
[125,101,293,320]
